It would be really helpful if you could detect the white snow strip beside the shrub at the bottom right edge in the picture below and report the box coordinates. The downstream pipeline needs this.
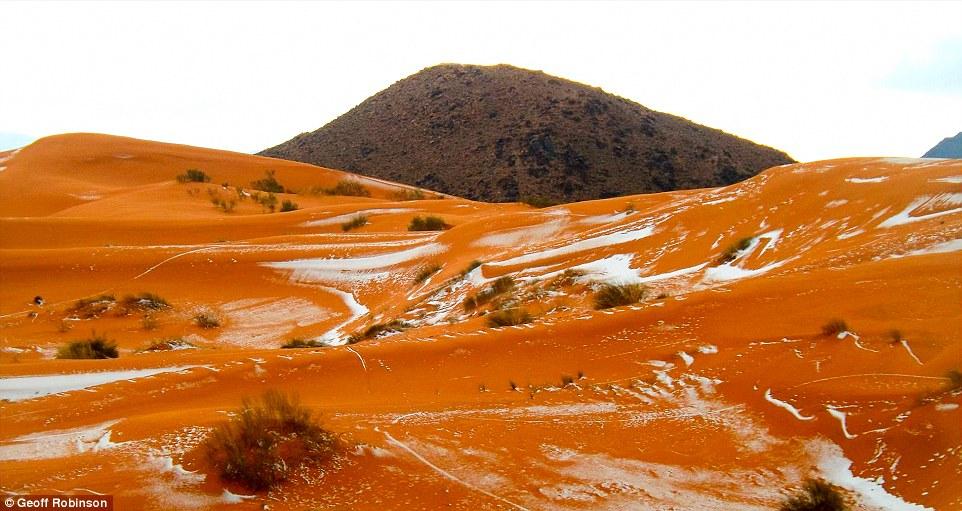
[816,441,934,511]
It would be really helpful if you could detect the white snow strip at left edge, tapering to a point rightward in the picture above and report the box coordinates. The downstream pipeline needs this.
[0,366,198,401]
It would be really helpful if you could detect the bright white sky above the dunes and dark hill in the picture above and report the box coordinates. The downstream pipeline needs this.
[0,1,962,161]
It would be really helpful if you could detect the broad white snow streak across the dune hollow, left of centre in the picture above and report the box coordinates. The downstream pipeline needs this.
[261,243,447,283]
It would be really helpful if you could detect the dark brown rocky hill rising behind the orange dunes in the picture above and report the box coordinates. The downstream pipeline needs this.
[259,64,793,202]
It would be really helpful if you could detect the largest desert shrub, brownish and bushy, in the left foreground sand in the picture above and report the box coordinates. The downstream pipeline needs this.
[205,391,337,491]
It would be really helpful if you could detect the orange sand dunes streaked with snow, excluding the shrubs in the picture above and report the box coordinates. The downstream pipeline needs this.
[0,135,962,510]
